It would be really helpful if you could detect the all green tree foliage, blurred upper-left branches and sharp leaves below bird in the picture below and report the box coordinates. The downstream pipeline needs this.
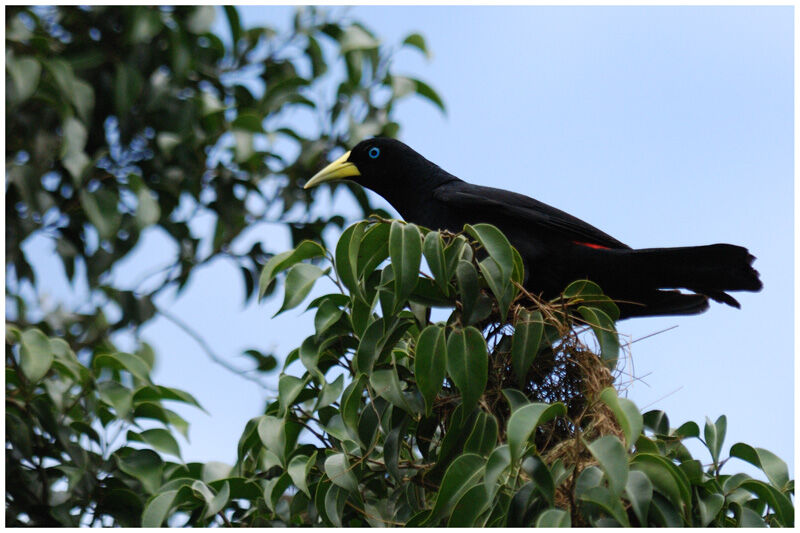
[6,7,794,526]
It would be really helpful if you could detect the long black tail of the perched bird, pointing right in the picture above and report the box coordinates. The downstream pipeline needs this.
[625,244,763,308]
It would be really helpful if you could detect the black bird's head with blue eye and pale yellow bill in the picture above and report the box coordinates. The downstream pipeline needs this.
[305,137,440,195]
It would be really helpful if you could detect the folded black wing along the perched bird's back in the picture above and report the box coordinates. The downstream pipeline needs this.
[433,180,630,248]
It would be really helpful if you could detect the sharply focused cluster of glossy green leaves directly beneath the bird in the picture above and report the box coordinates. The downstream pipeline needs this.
[134,220,794,527]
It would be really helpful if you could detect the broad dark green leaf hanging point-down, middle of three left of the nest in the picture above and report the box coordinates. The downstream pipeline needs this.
[447,326,489,414]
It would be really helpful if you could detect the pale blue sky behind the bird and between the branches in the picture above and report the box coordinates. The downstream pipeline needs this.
[26,6,794,473]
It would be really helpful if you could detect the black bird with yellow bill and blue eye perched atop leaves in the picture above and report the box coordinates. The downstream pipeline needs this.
[305,138,762,318]
